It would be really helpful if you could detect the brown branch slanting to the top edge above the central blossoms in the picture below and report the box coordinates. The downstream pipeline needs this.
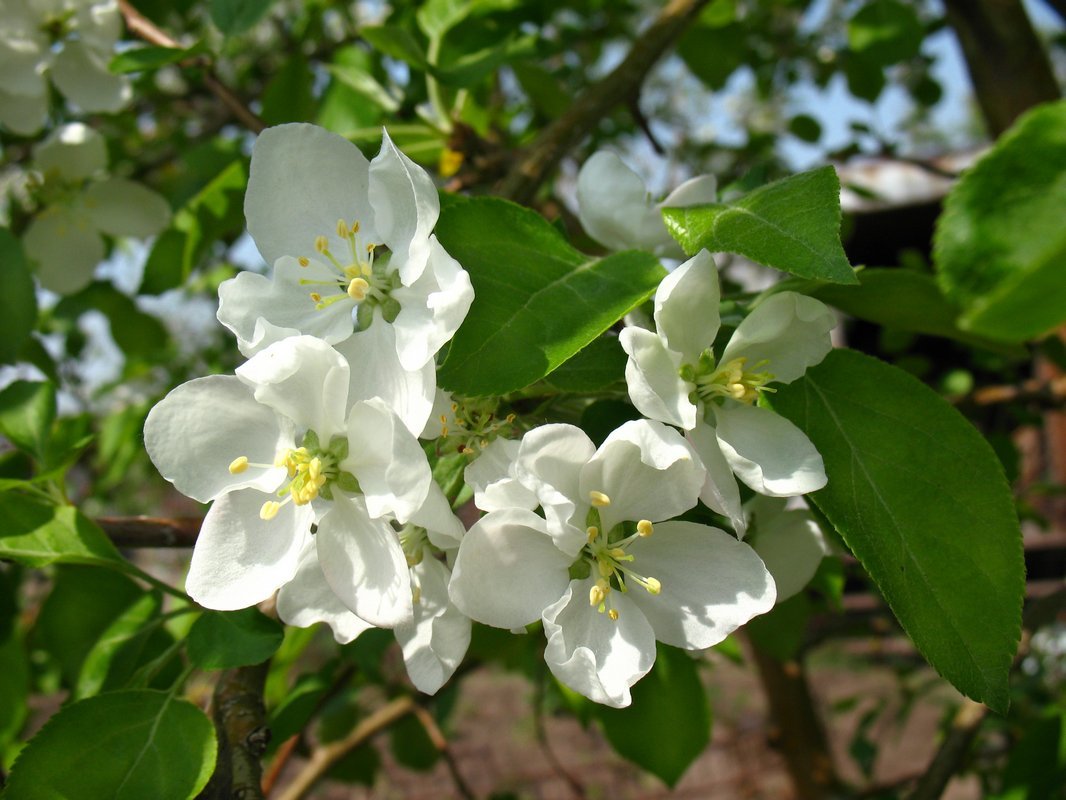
[499,0,708,204]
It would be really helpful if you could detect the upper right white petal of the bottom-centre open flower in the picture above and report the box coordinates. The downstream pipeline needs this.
[581,419,706,530]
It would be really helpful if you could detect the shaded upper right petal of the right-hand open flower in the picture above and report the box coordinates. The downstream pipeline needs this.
[722,291,837,383]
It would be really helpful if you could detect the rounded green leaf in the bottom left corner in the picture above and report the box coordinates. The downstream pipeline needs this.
[6,689,216,800]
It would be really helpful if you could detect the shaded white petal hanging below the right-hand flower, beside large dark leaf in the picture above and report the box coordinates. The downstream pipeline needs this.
[750,510,825,602]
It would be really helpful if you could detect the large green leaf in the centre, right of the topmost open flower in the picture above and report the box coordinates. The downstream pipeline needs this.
[436,197,664,396]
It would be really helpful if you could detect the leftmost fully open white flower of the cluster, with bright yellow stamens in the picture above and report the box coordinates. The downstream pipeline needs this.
[145,336,431,627]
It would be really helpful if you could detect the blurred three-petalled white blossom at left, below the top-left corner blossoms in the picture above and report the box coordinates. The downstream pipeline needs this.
[22,123,171,294]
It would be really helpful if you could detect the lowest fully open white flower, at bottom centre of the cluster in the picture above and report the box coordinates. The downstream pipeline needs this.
[450,420,775,707]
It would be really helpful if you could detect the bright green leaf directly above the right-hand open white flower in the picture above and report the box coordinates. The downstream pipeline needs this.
[663,166,858,284]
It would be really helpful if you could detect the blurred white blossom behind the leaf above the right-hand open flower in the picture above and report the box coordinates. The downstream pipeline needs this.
[578,150,717,258]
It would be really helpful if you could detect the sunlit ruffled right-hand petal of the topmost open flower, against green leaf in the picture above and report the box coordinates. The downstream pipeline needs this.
[392,236,473,370]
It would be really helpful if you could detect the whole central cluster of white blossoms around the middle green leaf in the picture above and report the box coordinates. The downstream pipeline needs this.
[145,136,833,706]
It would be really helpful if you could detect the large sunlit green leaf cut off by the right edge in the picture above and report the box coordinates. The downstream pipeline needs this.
[933,101,1066,341]
